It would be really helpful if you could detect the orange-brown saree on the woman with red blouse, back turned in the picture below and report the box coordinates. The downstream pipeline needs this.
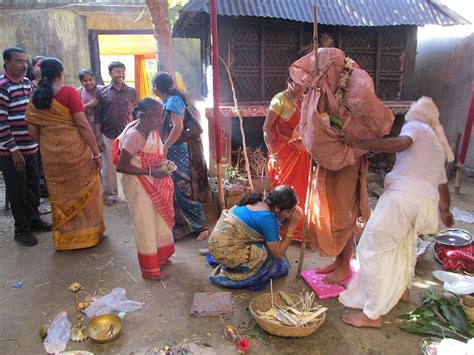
[26,99,105,250]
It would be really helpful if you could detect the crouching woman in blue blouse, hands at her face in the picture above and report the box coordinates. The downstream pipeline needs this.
[209,185,303,291]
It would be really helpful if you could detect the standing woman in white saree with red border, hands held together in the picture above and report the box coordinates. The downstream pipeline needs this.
[113,98,174,280]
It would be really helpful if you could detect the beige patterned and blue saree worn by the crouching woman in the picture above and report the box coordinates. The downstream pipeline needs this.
[208,210,290,291]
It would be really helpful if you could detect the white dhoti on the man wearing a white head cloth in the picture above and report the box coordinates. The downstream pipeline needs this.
[339,190,438,319]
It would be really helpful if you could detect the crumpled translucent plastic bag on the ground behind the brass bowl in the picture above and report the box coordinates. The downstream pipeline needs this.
[84,287,143,318]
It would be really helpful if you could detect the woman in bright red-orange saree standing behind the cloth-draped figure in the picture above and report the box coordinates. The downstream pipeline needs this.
[263,78,310,241]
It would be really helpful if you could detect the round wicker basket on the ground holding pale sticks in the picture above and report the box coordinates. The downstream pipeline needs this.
[249,293,326,337]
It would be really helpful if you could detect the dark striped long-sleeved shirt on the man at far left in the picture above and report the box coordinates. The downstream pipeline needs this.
[0,72,38,156]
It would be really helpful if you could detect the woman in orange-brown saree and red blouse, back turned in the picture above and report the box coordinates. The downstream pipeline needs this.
[26,58,105,250]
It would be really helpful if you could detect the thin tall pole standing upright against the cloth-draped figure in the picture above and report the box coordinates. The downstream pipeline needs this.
[296,0,319,277]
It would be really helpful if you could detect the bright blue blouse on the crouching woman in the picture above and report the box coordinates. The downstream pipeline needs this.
[232,206,280,243]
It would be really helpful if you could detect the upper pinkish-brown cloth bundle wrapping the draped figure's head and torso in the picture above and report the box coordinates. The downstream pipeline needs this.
[290,48,394,171]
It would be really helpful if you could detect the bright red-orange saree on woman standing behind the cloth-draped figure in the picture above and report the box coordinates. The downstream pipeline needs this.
[268,98,311,241]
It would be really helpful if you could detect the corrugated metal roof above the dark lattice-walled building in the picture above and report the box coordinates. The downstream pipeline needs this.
[181,0,461,26]
